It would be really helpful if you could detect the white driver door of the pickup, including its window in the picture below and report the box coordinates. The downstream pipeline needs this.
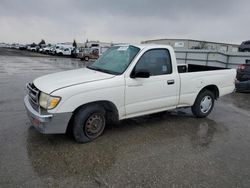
[125,49,179,117]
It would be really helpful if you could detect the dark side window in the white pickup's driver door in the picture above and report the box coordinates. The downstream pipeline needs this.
[135,49,172,76]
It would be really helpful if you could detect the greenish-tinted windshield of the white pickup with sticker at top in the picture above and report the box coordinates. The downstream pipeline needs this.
[87,45,140,75]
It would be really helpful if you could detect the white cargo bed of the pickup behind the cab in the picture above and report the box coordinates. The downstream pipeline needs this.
[178,64,236,107]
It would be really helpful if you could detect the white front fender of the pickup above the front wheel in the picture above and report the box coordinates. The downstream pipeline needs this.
[49,79,125,118]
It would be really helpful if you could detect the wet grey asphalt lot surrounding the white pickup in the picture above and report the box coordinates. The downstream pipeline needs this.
[0,49,250,188]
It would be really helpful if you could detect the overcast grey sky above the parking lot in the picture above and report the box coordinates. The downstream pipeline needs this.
[0,0,250,43]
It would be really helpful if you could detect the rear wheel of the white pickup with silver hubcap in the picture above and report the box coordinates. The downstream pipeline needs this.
[191,90,214,118]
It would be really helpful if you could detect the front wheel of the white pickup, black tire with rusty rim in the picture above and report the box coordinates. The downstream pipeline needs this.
[73,104,106,143]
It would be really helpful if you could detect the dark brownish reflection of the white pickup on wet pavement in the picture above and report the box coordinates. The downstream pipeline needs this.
[27,111,223,183]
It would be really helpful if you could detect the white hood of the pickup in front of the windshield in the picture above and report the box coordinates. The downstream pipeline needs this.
[33,68,114,94]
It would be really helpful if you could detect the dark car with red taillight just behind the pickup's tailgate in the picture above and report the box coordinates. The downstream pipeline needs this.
[235,60,250,92]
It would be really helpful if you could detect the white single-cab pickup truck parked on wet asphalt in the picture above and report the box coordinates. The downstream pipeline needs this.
[24,45,236,143]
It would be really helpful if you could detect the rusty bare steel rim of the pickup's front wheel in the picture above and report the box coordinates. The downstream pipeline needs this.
[85,113,105,139]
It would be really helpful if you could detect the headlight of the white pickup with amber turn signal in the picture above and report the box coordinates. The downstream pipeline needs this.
[39,92,61,110]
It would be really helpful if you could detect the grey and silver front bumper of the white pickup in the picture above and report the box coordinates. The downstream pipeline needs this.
[24,95,72,134]
